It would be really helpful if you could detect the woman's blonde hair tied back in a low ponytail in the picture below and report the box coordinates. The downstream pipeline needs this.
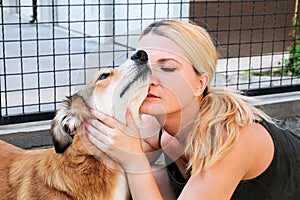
[140,20,270,175]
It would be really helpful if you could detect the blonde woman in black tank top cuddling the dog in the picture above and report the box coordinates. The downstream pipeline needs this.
[87,20,300,200]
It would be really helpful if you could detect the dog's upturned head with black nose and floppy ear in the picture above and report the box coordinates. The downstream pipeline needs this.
[51,50,151,153]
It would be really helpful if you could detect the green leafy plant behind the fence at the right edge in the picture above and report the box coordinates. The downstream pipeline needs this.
[283,18,300,76]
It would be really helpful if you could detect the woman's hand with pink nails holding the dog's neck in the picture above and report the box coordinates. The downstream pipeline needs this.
[86,109,148,172]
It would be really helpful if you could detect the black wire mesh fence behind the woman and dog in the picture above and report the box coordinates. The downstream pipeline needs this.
[0,0,300,124]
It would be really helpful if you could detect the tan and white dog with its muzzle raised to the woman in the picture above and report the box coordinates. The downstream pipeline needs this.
[0,50,151,200]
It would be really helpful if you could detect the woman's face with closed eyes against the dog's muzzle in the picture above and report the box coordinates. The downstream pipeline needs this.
[138,34,206,116]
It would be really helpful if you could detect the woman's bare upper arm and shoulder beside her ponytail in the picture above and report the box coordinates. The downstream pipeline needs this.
[177,123,272,199]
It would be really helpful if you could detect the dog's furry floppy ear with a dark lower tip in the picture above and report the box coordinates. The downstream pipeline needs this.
[51,97,75,153]
